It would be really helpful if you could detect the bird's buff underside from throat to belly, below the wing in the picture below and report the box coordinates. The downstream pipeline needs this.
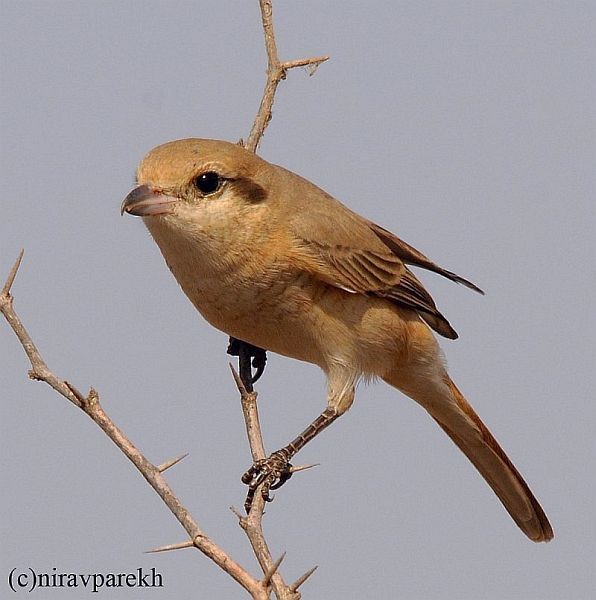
[149,221,420,377]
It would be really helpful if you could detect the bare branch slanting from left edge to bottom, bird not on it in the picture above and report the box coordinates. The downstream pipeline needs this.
[0,252,269,600]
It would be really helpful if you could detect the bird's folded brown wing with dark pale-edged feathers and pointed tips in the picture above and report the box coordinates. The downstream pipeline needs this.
[291,198,480,339]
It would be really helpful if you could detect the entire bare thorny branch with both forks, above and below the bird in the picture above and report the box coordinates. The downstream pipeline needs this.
[0,0,329,600]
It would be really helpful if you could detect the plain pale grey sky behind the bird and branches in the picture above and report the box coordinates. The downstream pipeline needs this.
[0,0,596,600]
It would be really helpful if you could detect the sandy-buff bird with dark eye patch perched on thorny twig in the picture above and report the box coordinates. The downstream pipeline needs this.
[121,138,554,542]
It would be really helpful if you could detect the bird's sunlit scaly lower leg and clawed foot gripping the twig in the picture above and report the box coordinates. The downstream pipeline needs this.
[242,406,343,513]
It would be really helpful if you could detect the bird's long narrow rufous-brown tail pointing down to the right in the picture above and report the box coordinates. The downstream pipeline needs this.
[392,375,554,542]
